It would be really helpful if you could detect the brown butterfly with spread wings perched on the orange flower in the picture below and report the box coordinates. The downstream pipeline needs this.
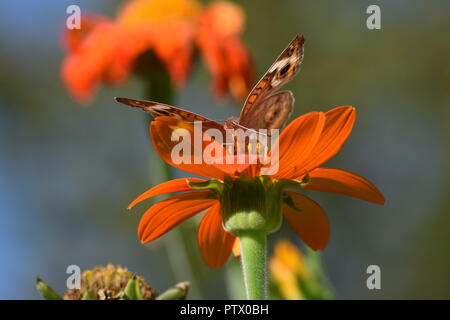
[115,35,305,132]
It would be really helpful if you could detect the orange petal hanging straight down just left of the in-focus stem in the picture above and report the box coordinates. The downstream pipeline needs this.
[197,202,236,268]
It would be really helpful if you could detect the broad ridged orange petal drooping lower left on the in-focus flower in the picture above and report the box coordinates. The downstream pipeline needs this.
[138,191,217,243]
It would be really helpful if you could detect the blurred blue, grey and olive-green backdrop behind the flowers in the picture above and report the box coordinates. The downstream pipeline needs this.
[0,0,450,299]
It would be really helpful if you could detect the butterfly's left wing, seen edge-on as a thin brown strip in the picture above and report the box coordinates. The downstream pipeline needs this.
[115,98,224,132]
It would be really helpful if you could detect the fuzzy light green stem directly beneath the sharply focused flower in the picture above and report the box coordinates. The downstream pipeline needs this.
[239,231,267,300]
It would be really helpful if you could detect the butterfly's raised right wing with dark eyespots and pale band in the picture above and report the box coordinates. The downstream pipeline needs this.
[239,36,305,129]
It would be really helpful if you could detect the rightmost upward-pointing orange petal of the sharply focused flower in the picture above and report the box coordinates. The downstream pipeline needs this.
[305,106,356,171]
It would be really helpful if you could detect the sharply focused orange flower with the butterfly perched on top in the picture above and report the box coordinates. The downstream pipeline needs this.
[129,106,384,267]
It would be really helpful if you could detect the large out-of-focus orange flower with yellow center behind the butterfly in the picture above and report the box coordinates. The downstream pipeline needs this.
[62,0,252,103]
